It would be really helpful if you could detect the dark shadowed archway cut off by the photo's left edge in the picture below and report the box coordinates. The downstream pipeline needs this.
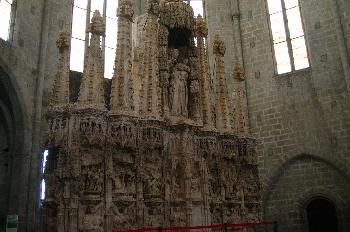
[0,60,25,223]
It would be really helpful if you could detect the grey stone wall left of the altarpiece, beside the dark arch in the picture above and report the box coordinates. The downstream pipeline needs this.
[0,0,71,231]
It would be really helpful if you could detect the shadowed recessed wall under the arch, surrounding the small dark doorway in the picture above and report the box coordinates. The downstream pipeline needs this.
[264,155,350,232]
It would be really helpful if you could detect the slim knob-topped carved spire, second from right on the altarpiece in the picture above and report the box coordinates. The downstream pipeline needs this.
[214,35,232,132]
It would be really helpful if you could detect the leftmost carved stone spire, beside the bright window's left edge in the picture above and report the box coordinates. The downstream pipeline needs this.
[51,31,70,106]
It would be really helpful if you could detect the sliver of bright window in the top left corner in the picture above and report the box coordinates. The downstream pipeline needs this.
[0,0,15,40]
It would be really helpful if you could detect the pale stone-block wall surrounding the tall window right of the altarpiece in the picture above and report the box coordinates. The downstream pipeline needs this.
[240,0,350,231]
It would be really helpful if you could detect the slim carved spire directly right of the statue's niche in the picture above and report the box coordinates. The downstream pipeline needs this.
[196,15,213,128]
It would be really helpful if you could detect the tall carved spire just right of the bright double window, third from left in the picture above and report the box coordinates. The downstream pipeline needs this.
[111,0,134,112]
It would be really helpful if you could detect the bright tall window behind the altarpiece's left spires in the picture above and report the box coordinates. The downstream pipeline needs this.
[70,0,118,78]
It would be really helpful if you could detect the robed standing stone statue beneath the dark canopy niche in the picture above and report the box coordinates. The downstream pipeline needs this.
[170,59,190,118]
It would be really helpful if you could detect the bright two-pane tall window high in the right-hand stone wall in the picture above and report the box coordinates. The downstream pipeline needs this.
[267,0,310,74]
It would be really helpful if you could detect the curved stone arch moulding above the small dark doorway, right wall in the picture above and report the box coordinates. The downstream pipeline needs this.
[262,154,350,209]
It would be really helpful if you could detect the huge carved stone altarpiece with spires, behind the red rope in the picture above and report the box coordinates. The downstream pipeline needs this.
[43,0,261,232]
